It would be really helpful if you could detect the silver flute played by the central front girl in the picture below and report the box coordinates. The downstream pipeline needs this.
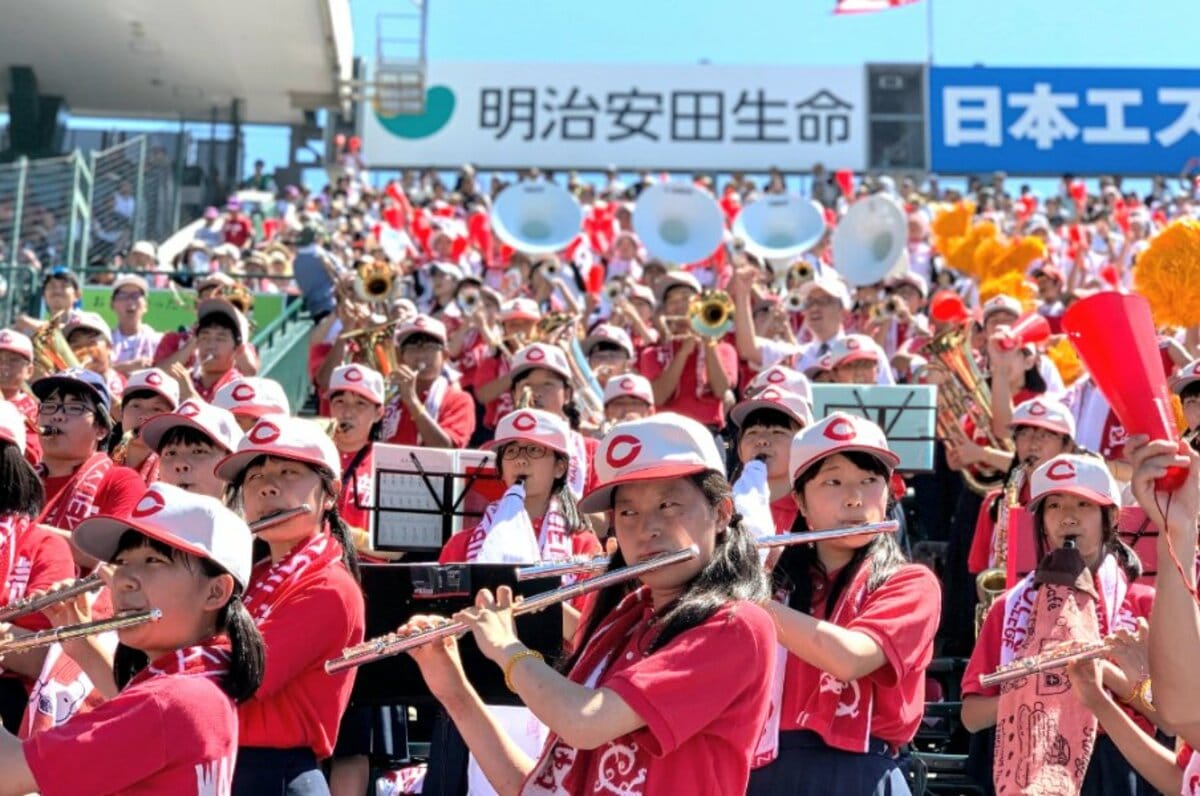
[325,545,700,675]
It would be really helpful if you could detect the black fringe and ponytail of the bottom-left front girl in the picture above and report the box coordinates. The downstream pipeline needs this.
[113,531,266,702]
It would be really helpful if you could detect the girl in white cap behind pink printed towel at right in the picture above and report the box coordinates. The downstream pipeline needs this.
[962,454,1154,794]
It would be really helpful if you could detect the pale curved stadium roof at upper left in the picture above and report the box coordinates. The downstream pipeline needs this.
[0,0,354,124]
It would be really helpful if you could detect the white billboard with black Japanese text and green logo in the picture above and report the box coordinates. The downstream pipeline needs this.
[360,64,866,170]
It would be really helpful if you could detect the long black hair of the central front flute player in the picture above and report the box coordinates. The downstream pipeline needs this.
[559,471,770,672]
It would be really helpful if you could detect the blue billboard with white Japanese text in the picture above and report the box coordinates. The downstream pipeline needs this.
[929,67,1200,174]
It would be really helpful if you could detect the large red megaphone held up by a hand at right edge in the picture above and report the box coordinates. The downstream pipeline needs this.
[1062,292,1188,492]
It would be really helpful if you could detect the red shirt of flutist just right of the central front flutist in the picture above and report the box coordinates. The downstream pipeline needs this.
[780,564,942,752]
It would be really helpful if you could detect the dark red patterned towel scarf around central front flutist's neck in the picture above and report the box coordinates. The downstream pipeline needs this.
[521,586,653,796]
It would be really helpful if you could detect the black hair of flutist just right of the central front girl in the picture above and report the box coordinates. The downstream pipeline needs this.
[774,450,908,614]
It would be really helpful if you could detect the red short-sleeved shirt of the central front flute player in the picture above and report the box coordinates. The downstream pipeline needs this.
[535,602,775,796]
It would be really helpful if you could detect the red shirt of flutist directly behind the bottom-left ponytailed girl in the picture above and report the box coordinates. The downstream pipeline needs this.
[238,562,366,760]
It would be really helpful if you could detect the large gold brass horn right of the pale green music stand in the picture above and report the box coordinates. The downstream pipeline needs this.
[922,327,1013,495]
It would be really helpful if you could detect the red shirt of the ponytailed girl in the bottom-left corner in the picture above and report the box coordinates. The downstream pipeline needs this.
[24,675,238,796]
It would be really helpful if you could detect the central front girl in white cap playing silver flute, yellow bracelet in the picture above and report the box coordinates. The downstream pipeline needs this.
[402,414,773,796]
